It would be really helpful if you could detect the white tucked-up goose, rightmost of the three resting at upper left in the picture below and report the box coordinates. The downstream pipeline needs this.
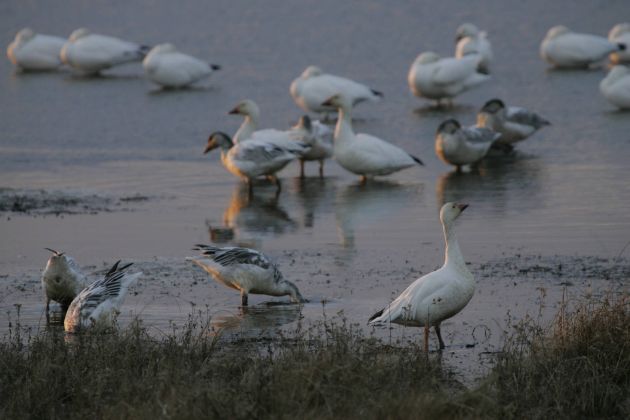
[142,44,221,88]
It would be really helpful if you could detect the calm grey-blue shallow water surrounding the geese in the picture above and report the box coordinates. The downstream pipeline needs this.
[0,0,630,380]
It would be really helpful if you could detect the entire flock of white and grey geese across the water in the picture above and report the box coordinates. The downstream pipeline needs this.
[14,23,630,350]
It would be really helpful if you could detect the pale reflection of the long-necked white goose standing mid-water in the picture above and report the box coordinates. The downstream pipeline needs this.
[335,180,423,248]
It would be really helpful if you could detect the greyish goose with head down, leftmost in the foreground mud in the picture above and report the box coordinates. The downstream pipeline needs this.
[42,248,87,321]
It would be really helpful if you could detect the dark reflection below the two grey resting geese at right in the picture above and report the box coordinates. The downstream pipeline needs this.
[435,152,543,214]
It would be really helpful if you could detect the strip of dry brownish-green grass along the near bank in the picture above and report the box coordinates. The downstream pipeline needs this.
[0,299,630,419]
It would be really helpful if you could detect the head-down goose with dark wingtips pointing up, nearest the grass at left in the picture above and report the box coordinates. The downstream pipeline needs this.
[63,261,142,333]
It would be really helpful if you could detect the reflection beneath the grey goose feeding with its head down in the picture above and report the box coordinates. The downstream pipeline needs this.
[210,302,302,336]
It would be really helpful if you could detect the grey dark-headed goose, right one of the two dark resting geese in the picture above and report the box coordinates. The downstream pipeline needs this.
[477,98,551,150]
